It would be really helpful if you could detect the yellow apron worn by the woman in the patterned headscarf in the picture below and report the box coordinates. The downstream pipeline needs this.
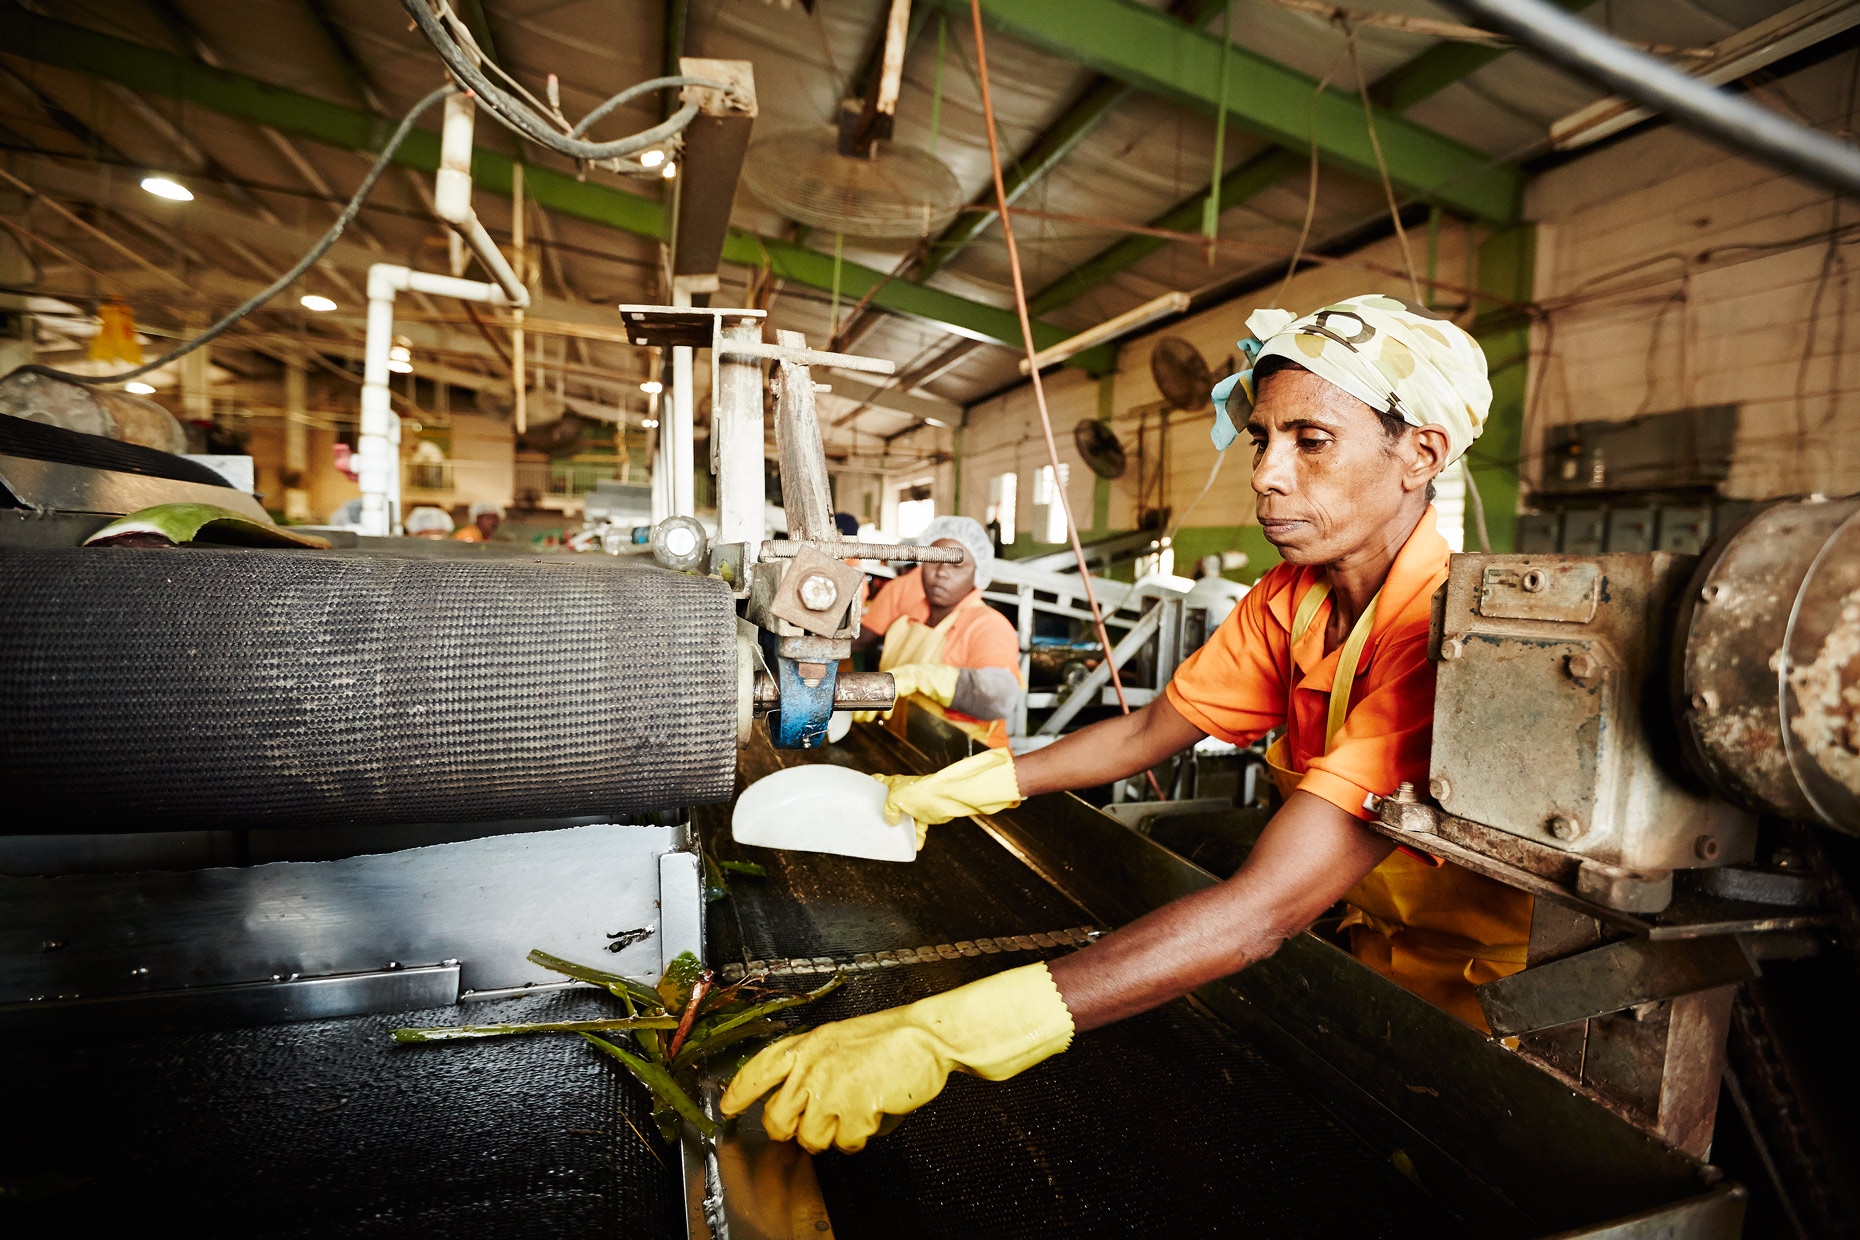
[1267,582,1531,1030]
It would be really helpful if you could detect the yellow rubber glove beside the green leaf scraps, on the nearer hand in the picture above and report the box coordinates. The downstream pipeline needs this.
[724,965,1071,1154]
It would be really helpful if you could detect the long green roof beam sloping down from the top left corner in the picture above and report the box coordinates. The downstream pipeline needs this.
[0,4,1112,368]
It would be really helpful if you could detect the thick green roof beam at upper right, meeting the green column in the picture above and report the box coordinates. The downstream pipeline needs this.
[937,0,1523,225]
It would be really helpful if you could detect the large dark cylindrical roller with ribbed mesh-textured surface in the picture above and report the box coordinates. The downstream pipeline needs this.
[0,547,737,833]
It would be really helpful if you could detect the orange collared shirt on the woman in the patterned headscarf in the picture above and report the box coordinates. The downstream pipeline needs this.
[1168,508,1449,820]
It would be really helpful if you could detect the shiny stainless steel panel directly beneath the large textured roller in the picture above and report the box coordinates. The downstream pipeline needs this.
[0,825,684,1002]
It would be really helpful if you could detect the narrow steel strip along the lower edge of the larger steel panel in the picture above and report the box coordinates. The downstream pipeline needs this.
[0,961,459,1036]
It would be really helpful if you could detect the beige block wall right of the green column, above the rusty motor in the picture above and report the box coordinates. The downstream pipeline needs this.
[1525,54,1860,498]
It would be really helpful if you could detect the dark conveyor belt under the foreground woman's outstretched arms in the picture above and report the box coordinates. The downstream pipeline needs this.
[696,729,1466,1240]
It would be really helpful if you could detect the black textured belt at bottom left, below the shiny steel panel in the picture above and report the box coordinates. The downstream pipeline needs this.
[0,991,684,1240]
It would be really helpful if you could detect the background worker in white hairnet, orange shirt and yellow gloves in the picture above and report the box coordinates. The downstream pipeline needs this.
[852,517,1021,751]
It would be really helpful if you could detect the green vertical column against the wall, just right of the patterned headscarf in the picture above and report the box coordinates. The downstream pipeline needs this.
[1466,223,1536,552]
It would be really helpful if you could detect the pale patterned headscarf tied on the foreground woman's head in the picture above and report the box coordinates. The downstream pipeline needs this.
[1213,294,1492,463]
